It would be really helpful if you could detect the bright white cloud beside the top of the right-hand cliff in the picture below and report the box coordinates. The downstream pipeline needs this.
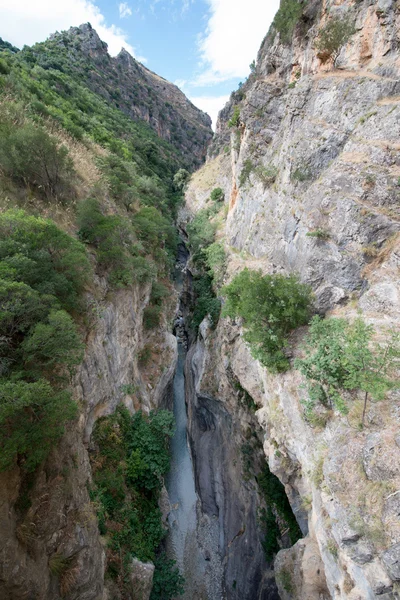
[196,0,279,85]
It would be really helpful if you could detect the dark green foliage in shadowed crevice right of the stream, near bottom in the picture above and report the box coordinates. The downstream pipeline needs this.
[257,462,302,561]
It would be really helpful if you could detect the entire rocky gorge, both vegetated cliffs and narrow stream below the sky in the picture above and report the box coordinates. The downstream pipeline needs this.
[0,0,400,600]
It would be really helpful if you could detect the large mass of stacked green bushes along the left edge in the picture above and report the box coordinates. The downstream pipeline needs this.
[0,211,90,471]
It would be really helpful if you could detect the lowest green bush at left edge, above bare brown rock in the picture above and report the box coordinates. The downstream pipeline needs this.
[0,379,77,472]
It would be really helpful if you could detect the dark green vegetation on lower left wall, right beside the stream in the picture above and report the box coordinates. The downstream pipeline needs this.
[91,407,183,600]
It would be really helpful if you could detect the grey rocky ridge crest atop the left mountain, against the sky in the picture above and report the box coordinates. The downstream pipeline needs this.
[50,23,212,168]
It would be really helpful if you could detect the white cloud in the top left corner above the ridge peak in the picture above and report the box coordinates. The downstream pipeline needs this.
[0,0,142,60]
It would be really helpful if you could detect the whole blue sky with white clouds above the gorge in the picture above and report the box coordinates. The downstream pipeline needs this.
[0,0,279,126]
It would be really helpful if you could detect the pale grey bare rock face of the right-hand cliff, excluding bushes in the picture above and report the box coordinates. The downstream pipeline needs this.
[181,0,400,600]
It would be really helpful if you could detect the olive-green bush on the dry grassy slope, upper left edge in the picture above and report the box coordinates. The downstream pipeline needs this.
[0,118,74,198]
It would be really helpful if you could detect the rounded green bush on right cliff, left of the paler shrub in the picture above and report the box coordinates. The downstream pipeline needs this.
[222,269,312,372]
